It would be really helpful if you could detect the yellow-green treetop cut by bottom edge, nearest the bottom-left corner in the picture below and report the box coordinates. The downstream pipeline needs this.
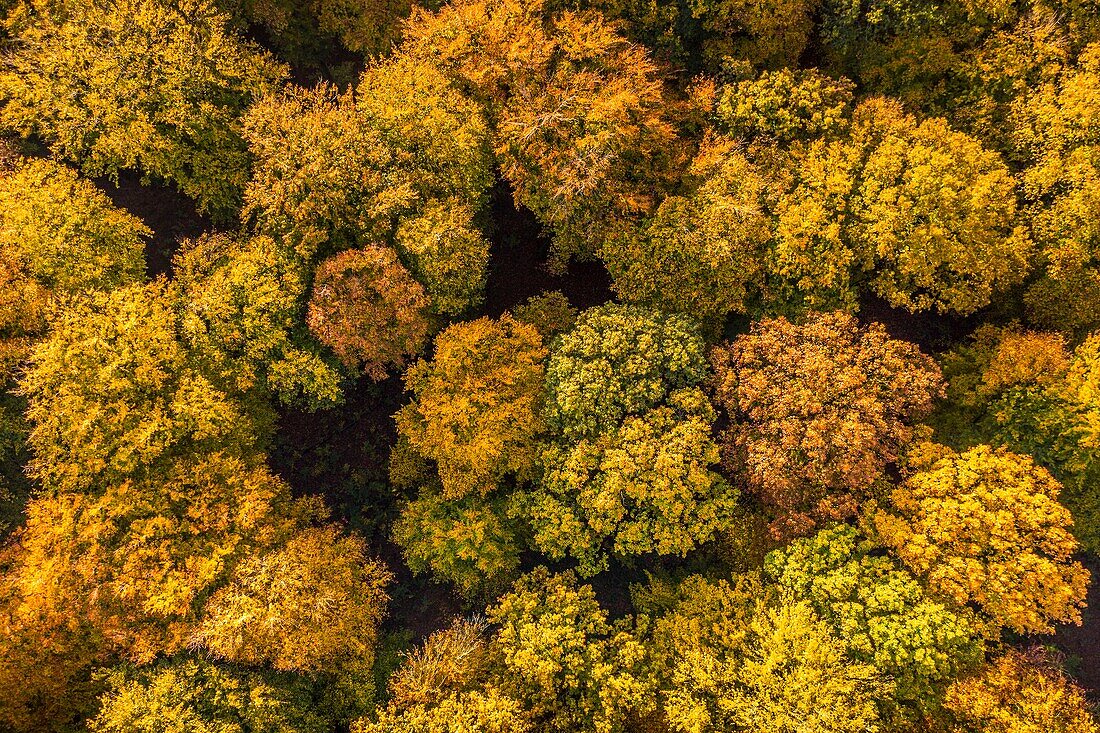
[89,658,331,733]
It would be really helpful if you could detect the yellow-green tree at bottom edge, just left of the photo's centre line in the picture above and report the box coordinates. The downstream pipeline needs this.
[488,568,653,733]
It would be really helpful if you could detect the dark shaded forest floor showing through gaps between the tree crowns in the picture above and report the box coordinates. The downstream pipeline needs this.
[107,173,1100,700]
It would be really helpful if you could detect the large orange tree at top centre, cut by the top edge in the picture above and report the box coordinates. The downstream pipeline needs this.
[404,0,679,264]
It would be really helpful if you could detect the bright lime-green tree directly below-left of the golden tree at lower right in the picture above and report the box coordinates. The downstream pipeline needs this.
[765,525,982,724]
